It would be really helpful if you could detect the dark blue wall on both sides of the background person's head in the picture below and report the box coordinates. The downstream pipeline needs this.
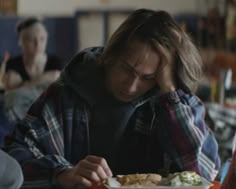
[0,17,77,63]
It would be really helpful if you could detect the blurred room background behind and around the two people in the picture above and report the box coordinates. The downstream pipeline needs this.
[0,0,236,162]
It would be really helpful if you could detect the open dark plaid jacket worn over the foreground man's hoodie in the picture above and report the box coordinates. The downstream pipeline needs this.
[8,48,220,188]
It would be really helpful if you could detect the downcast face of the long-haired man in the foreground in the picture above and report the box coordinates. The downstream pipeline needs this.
[107,41,160,102]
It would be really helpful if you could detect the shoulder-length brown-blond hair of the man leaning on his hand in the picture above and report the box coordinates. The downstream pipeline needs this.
[102,9,202,92]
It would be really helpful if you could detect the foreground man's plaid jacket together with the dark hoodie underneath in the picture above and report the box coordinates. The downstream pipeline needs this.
[9,48,220,188]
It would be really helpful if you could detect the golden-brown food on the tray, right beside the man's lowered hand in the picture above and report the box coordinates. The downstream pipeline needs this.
[117,173,162,186]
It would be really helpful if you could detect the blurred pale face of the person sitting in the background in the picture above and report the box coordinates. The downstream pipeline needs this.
[20,23,47,56]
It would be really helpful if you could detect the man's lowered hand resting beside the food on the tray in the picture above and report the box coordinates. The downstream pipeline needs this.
[56,155,112,189]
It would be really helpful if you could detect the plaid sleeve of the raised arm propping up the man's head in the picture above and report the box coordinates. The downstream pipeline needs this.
[157,90,220,181]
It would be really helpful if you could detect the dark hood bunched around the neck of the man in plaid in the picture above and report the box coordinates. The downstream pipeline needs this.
[61,47,157,106]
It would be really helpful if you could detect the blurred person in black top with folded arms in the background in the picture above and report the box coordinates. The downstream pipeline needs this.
[4,17,62,121]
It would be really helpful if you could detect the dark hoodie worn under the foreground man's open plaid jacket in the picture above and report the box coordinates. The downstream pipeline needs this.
[62,48,162,173]
